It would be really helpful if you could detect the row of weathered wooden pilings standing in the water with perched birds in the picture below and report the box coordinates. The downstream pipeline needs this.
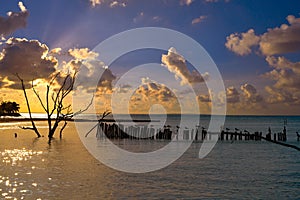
[96,122,286,141]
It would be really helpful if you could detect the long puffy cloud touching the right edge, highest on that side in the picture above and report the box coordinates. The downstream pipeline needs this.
[225,15,300,56]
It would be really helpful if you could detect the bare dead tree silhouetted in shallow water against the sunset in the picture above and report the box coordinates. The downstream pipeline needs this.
[17,72,93,144]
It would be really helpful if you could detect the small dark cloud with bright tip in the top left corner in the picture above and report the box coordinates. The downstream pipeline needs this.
[0,2,29,37]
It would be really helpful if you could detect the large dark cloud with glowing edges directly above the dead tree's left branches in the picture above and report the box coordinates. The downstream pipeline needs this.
[0,38,58,86]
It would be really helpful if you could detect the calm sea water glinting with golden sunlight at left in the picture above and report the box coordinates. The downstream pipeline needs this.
[0,115,300,199]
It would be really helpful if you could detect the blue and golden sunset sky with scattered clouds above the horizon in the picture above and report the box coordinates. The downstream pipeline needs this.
[0,0,300,115]
